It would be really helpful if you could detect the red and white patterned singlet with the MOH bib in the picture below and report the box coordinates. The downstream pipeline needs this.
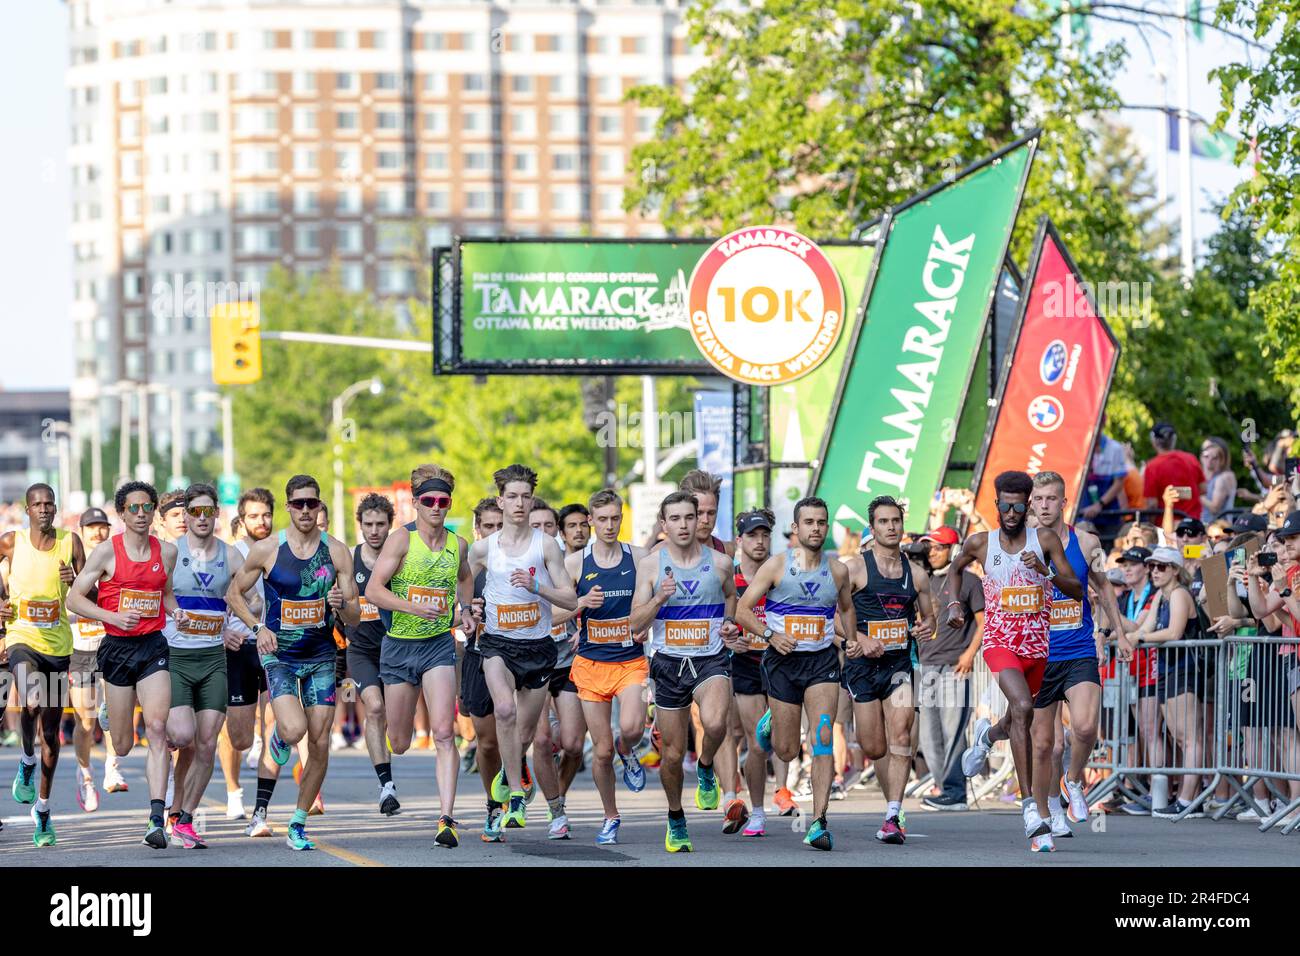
[983,528,1052,659]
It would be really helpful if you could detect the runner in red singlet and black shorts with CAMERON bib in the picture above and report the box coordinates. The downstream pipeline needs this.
[68,481,185,849]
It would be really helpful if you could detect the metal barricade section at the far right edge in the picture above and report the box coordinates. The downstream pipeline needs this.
[1216,636,1300,834]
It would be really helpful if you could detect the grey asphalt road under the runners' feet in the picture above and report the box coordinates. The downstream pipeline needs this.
[0,748,1300,868]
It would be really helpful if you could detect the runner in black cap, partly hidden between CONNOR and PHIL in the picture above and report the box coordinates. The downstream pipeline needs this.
[719,509,796,836]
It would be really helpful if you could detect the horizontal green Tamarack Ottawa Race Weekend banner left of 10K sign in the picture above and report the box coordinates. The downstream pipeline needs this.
[450,239,712,375]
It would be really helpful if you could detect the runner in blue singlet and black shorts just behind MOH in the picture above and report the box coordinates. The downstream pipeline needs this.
[1030,471,1132,836]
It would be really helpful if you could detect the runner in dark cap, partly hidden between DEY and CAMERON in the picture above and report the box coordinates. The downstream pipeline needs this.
[68,507,120,813]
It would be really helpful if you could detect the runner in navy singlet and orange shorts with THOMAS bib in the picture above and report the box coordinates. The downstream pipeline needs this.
[564,488,650,845]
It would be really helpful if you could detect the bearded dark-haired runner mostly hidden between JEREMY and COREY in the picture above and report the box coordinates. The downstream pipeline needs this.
[217,488,276,836]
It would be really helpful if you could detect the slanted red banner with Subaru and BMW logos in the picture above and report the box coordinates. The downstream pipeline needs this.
[975,217,1119,524]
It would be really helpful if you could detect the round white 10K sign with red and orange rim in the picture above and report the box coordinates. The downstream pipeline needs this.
[688,226,844,385]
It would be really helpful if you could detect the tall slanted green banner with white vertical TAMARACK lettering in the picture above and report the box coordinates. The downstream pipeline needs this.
[814,133,1037,528]
